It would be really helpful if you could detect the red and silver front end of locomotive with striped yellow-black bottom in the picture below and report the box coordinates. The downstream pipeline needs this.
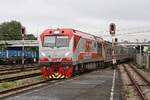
[39,29,73,79]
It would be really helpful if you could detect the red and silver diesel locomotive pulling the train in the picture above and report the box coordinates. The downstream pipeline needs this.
[39,28,133,79]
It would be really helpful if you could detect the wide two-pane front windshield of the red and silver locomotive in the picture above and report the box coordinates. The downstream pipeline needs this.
[44,36,69,47]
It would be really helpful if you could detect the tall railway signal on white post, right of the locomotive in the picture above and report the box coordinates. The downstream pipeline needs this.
[109,23,118,69]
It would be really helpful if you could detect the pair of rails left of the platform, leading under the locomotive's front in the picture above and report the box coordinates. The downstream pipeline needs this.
[0,72,44,97]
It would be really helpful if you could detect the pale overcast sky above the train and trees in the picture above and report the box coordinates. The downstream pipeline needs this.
[0,0,150,41]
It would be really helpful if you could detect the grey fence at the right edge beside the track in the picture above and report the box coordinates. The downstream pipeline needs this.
[134,53,150,70]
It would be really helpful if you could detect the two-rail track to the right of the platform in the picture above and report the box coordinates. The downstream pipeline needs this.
[123,64,150,100]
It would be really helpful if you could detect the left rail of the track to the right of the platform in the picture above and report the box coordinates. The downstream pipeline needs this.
[123,65,147,100]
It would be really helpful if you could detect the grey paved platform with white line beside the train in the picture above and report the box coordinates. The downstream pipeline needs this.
[3,68,123,100]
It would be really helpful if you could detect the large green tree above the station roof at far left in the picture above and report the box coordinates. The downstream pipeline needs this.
[0,21,22,40]
